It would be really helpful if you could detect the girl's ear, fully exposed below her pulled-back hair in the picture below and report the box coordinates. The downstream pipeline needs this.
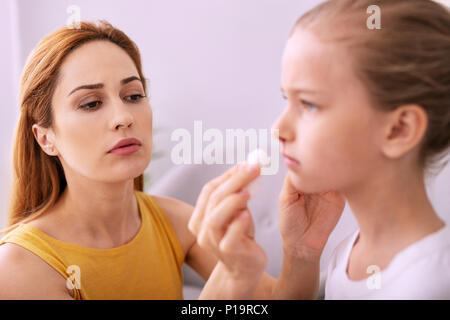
[382,104,428,159]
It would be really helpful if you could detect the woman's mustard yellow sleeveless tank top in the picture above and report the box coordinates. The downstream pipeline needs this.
[0,191,184,300]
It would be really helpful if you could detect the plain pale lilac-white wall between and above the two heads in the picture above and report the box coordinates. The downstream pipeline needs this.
[8,0,314,188]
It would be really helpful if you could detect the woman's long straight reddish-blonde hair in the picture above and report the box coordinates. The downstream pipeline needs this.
[2,21,146,233]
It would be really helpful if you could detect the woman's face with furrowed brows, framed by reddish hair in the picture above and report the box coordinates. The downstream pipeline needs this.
[44,41,152,182]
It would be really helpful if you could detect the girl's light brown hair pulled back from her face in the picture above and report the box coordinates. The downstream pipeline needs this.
[291,0,450,169]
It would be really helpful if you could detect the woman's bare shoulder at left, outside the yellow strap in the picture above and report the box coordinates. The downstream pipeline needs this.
[0,243,72,299]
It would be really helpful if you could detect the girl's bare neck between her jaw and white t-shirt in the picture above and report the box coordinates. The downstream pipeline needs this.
[344,162,445,250]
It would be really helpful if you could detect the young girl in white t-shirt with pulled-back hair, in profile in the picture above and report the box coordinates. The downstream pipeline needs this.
[190,0,450,299]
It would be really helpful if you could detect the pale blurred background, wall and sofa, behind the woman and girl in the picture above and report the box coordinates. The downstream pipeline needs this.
[0,0,450,298]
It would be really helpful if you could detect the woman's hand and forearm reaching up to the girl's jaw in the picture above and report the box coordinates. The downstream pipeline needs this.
[271,173,345,299]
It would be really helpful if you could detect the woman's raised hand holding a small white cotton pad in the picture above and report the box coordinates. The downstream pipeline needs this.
[188,164,267,282]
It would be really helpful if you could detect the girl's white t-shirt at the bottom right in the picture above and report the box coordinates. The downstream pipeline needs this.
[325,225,450,300]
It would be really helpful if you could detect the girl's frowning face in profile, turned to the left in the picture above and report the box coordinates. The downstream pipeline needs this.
[274,29,390,193]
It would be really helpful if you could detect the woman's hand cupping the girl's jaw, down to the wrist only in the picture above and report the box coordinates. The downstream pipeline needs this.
[278,173,345,261]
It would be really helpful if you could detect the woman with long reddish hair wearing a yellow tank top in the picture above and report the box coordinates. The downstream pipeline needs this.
[0,22,340,299]
